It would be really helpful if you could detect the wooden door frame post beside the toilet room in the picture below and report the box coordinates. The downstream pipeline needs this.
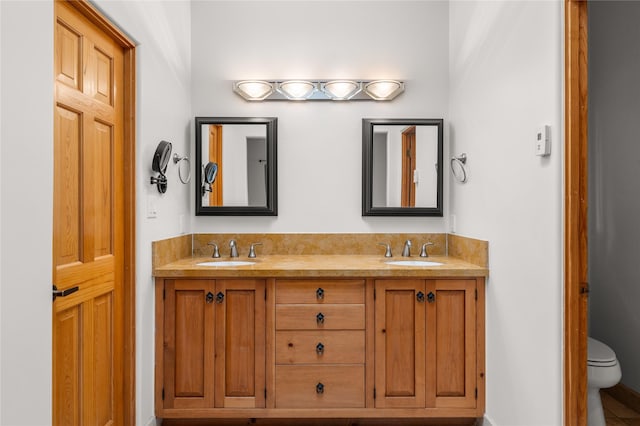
[564,0,588,426]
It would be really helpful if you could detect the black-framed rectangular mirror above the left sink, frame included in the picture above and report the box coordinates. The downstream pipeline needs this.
[195,117,278,216]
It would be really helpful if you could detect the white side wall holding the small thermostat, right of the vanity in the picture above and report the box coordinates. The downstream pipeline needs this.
[449,1,563,426]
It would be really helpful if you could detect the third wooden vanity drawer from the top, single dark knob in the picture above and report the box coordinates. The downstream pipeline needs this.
[276,330,365,364]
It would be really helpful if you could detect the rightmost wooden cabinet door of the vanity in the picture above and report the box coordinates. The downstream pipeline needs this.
[426,279,477,408]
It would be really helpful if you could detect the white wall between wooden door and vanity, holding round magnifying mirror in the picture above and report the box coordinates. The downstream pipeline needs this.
[89,0,193,425]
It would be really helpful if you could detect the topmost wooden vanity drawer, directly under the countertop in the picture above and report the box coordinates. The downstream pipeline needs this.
[276,280,364,304]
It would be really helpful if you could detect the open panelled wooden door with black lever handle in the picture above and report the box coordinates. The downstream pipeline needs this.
[52,1,133,425]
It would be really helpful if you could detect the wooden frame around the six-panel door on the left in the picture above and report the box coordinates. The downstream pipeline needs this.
[62,0,136,425]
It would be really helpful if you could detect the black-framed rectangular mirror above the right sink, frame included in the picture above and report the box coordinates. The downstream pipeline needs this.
[362,118,443,217]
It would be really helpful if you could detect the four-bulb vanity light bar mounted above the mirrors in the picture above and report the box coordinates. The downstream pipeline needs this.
[233,80,404,101]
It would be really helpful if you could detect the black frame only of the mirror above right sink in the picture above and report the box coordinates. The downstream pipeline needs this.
[362,118,444,217]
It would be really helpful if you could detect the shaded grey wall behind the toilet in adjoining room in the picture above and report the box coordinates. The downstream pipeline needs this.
[589,1,640,392]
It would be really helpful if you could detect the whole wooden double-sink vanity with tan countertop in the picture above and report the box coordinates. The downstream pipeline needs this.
[154,235,488,419]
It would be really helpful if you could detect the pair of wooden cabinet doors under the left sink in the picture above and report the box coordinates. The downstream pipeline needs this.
[156,279,265,417]
